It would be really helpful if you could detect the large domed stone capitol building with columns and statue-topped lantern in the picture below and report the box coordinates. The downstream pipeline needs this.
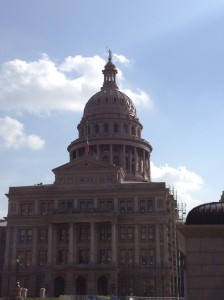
[1,52,177,297]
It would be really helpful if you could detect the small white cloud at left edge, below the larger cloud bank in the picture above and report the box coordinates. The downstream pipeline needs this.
[0,116,44,150]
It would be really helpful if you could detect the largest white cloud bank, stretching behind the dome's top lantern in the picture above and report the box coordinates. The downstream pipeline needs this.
[0,54,151,114]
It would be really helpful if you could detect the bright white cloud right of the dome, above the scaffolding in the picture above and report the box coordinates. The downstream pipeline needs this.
[151,163,204,211]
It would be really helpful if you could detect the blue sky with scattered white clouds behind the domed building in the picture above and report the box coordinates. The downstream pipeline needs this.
[0,0,224,216]
